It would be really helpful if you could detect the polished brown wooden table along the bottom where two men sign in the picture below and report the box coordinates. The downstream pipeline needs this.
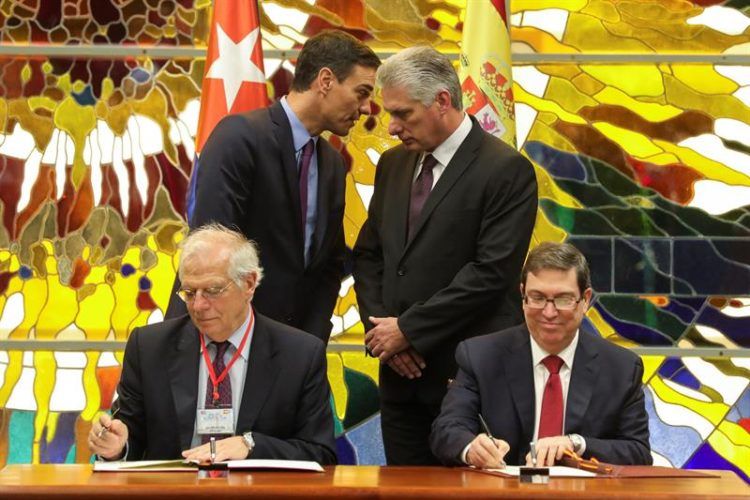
[0,465,750,500]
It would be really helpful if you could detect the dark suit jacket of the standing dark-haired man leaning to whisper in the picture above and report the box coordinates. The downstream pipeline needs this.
[176,102,346,342]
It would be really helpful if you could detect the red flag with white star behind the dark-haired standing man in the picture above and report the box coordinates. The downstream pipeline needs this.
[187,0,268,220]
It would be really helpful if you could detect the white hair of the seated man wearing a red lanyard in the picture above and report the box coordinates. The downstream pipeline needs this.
[179,222,263,285]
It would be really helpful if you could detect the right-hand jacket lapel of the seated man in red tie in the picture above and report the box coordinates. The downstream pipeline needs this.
[565,331,601,434]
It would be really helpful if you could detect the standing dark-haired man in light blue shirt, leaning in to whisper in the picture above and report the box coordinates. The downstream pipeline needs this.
[167,31,380,342]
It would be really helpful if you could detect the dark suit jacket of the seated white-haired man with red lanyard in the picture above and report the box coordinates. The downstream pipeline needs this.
[117,314,336,464]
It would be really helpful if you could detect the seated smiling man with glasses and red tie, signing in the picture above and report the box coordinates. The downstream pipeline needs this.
[431,243,652,468]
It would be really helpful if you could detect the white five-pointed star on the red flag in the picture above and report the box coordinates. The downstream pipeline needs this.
[206,25,266,112]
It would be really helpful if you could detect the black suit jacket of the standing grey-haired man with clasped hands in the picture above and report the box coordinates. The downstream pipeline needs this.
[354,117,537,405]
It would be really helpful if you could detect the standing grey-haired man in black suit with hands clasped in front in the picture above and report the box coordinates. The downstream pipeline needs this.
[354,47,537,465]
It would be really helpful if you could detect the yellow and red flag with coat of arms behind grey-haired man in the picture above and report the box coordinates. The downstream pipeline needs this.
[460,0,516,147]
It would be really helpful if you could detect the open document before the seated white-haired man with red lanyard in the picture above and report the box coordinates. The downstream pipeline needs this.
[94,458,323,472]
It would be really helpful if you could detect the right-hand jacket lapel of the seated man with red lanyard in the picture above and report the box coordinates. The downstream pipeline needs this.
[237,313,281,432]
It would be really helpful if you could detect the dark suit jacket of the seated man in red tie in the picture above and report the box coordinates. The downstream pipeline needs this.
[430,325,651,465]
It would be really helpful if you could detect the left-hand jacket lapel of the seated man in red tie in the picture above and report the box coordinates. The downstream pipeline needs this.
[504,326,534,443]
